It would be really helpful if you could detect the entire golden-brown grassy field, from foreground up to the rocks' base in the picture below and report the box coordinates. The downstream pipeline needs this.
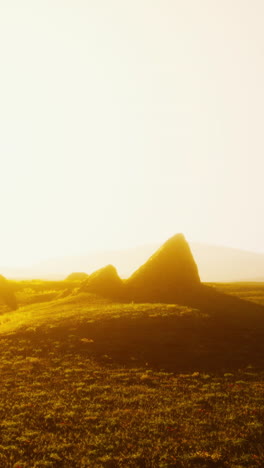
[0,281,264,468]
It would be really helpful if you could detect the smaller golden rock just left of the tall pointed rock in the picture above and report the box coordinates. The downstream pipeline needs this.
[81,265,123,298]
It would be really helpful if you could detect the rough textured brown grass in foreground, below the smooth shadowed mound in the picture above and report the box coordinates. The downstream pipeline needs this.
[0,331,264,468]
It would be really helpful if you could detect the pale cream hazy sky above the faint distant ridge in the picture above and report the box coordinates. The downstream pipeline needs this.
[0,0,264,266]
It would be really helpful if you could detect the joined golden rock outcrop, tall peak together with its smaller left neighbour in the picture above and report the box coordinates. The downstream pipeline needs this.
[81,234,202,303]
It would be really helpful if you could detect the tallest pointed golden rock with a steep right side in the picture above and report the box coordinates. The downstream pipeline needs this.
[126,234,201,302]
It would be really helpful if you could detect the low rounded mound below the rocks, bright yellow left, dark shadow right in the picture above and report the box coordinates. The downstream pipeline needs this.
[0,288,264,371]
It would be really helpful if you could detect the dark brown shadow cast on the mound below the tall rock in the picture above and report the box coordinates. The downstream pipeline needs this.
[12,286,264,372]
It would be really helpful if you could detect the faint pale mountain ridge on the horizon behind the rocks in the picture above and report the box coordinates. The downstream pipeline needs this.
[0,242,264,282]
